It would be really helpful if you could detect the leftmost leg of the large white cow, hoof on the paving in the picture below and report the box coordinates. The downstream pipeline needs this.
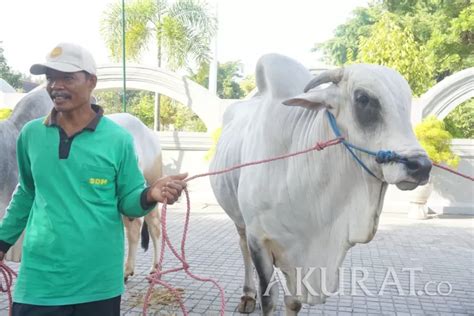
[236,226,257,314]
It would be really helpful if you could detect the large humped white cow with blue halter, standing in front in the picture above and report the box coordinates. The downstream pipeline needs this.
[210,54,431,315]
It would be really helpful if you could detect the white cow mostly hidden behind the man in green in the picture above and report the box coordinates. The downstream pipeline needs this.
[0,89,162,280]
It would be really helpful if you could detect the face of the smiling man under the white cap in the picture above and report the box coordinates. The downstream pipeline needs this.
[46,69,97,112]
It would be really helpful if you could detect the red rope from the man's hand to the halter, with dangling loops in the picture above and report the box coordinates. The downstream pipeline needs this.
[143,137,343,316]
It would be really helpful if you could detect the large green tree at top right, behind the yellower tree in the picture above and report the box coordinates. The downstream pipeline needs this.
[315,0,474,81]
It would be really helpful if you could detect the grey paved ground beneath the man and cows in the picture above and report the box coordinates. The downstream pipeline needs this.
[0,204,474,315]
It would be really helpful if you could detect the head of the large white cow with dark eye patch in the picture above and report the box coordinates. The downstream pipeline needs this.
[283,64,431,190]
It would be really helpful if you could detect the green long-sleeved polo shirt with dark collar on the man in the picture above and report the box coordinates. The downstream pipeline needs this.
[0,106,154,305]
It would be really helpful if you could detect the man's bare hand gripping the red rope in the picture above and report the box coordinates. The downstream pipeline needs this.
[146,173,188,204]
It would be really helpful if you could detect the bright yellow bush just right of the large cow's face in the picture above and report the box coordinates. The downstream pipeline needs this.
[415,116,459,167]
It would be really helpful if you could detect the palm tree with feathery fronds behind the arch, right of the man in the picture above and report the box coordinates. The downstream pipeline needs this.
[101,0,217,128]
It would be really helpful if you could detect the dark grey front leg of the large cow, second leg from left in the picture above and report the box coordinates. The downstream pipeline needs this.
[247,236,278,316]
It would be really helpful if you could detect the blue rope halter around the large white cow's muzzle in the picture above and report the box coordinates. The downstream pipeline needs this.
[326,111,406,178]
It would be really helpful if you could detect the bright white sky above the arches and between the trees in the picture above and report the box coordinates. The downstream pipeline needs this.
[0,0,368,74]
